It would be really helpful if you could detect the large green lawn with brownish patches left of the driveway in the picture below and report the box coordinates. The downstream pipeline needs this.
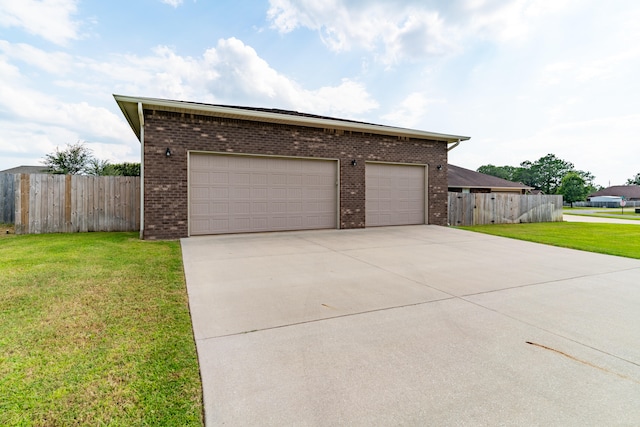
[0,233,203,426]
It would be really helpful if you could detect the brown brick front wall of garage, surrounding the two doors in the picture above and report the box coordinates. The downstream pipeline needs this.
[143,110,447,239]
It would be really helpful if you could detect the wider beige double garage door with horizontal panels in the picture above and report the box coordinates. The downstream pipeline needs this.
[189,153,337,235]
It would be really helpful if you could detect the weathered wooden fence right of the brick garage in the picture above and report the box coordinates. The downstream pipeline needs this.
[449,193,562,226]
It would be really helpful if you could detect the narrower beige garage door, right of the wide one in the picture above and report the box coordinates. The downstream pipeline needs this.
[365,163,426,227]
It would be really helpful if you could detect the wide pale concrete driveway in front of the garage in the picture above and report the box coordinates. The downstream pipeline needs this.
[182,226,640,426]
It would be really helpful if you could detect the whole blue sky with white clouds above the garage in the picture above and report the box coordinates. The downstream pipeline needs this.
[0,0,640,186]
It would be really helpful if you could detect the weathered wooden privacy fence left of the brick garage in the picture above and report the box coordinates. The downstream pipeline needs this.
[0,174,140,234]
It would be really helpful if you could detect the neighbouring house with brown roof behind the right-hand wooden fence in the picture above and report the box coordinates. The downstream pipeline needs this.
[447,164,534,194]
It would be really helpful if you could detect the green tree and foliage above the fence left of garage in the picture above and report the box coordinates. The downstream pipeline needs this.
[42,141,140,176]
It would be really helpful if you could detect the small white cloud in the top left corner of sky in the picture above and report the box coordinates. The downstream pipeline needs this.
[0,0,79,45]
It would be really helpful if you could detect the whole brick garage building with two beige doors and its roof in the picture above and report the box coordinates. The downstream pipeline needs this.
[114,95,469,239]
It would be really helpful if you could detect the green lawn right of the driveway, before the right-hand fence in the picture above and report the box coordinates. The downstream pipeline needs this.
[459,222,640,259]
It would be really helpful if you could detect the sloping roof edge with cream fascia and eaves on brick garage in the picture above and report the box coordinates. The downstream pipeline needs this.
[113,95,470,144]
